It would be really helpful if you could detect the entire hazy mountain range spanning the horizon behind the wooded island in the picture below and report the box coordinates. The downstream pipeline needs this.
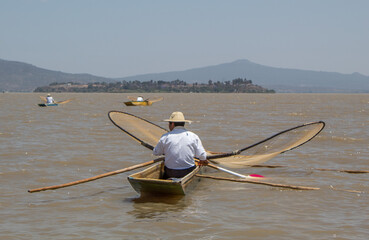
[0,59,369,93]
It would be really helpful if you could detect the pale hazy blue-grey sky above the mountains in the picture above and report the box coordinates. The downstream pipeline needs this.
[0,0,369,77]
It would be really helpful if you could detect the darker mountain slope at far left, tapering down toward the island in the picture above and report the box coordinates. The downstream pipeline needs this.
[0,59,112,92]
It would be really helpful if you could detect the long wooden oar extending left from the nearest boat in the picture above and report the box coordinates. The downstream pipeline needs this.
[28,157,164,193]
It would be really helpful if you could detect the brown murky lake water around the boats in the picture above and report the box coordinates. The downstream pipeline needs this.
[0,93,369,240]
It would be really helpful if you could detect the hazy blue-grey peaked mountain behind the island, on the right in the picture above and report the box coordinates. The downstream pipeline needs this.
[120,60,369,93]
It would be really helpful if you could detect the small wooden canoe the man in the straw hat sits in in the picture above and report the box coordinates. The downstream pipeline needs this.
[128,162,200,195]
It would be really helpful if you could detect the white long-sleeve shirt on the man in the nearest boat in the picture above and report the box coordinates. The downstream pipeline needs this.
[153,126,206,169]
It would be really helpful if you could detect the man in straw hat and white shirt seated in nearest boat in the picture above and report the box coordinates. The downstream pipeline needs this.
[153,112,208,179]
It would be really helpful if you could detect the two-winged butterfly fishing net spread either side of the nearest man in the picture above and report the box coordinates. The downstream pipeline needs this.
[109,111,325,168]
